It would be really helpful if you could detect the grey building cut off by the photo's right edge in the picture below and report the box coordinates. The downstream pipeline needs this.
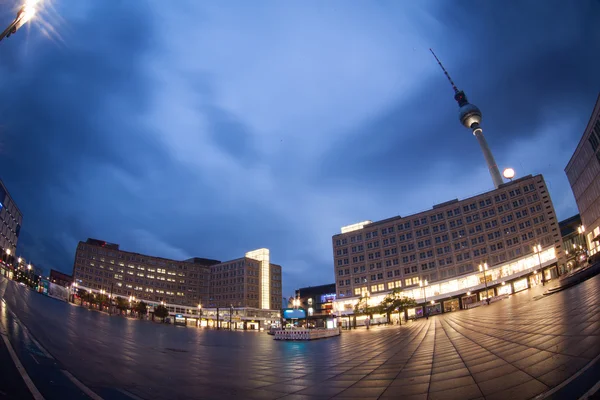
[565,95,600,256]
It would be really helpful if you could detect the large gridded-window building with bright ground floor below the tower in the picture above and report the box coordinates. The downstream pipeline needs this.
[332,175,564,315]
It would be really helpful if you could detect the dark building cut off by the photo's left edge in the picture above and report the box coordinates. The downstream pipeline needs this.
[0,180,23,275]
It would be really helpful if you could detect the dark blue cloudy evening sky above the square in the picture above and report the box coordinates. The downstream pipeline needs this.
[0,0,600,296]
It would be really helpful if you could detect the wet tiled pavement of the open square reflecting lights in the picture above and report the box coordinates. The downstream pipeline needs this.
[0,276,600,400]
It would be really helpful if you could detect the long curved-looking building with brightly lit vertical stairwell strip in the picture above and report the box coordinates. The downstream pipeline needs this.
[73,239,281,329]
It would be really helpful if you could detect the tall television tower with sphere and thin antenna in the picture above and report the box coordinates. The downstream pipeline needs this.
[429,49,504,189]
